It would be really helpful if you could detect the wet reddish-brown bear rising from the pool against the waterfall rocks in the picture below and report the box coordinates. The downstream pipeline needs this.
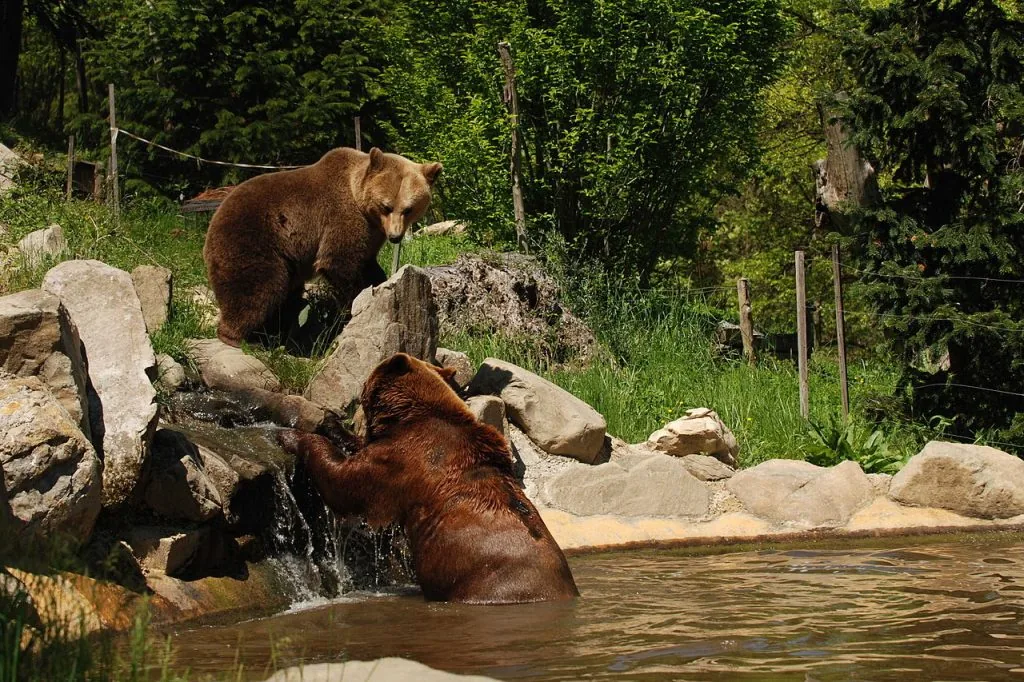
[279,353,580,604]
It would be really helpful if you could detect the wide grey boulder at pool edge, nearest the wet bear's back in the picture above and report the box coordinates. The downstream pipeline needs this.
[542,454,710,516]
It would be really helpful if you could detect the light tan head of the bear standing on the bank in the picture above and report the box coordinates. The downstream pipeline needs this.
[361,146,441,244]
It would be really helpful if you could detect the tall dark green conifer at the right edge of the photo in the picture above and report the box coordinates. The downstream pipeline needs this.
[845,0,1024,447]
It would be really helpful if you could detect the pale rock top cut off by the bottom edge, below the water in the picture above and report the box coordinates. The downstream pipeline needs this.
[264,658,494,682]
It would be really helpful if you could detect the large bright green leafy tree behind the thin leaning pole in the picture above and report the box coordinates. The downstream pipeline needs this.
[382,0,784,282]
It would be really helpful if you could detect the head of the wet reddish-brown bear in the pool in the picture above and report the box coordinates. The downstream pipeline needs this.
[359,353,458,439]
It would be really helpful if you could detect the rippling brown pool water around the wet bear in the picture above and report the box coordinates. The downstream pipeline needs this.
[167,536,1024,682]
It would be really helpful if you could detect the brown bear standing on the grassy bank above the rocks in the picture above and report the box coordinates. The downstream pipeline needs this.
[203,147,441,346]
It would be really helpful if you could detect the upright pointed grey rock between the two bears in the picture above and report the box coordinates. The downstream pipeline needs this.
[305,265,437,414]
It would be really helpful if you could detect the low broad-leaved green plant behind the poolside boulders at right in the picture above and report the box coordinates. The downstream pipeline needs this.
[807,417,909,474]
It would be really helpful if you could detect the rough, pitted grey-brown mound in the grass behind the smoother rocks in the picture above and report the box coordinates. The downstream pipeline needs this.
[425,254,598,363]
